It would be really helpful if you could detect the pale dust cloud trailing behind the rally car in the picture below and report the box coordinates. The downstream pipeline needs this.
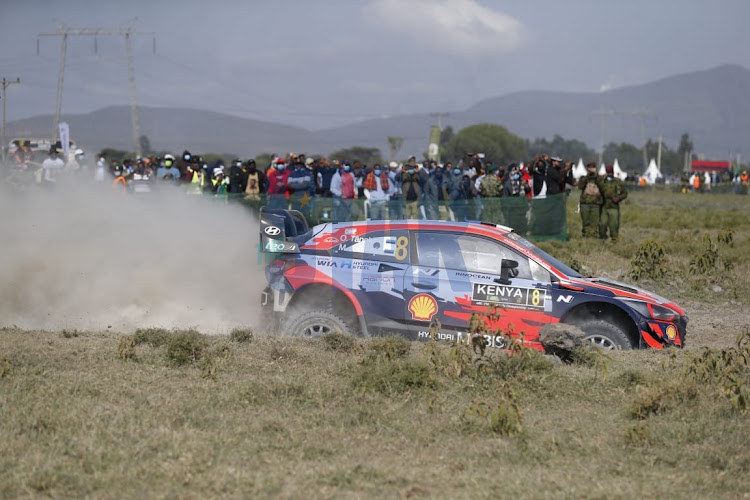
[0,184,265,333]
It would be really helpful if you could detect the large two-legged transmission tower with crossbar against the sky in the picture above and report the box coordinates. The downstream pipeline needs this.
[36,22,156,156]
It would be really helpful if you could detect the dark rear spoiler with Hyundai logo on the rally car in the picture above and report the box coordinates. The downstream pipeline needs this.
[260,207,310,253]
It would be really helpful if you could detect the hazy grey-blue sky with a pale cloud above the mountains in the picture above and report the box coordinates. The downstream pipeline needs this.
[0,0,750,130]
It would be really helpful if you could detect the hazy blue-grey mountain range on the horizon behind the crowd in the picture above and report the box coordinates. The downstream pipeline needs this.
[7,65,750,160]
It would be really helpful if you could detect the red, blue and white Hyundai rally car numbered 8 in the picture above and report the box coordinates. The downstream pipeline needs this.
[260,208,688,349]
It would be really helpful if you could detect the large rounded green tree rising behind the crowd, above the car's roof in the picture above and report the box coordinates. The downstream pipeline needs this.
[441,123,526,163]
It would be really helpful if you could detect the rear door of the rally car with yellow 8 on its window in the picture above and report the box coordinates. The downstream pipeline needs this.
[330,229,410,334]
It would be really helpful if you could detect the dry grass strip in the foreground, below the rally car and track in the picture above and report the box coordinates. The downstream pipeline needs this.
[0,329,750,498]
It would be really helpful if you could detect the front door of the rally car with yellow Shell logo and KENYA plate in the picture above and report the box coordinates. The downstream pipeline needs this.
[404,230,553,347]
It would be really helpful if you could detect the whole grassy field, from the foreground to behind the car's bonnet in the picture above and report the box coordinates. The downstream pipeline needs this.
[0,188,750,498]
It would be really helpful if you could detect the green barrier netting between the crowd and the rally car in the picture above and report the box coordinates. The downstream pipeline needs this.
[226,194,568,241]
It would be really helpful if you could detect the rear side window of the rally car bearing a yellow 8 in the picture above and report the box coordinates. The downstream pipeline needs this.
[333,231,410,264]
